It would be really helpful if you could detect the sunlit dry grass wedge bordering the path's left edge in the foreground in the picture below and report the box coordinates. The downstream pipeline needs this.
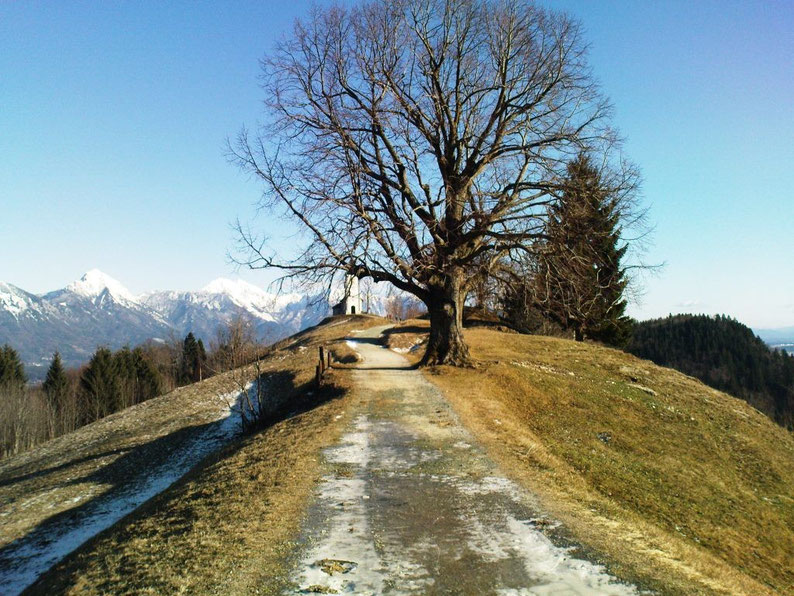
[31,384,346,594]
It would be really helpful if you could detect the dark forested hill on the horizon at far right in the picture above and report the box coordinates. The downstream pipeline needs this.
[626,315,794,429]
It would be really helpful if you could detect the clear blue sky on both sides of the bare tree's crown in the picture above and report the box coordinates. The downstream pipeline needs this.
[0,0,794,327]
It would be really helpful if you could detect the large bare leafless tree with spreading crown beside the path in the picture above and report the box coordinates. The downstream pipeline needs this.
[230,0,614,365]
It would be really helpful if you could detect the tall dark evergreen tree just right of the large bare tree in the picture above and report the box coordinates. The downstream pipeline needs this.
[533,154,631,345]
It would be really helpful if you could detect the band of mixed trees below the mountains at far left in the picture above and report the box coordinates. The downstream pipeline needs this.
[0,318,265,458]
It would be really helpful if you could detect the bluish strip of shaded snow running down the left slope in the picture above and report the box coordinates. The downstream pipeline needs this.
[0,383,254,596]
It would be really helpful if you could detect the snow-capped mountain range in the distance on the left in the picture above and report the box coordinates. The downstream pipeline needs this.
[0,269,329,380]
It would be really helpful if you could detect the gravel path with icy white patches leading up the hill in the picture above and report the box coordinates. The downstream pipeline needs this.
[288,328,636,595]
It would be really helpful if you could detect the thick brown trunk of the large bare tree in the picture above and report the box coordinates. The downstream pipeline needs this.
[421,268,471,366]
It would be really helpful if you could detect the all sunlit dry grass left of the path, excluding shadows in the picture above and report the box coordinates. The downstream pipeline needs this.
[2,316,383,594]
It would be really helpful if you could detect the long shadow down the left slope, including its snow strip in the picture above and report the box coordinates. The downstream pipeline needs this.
[0,373,345,594]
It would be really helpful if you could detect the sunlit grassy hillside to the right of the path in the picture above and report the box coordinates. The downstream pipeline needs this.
[391,322,794,594]
